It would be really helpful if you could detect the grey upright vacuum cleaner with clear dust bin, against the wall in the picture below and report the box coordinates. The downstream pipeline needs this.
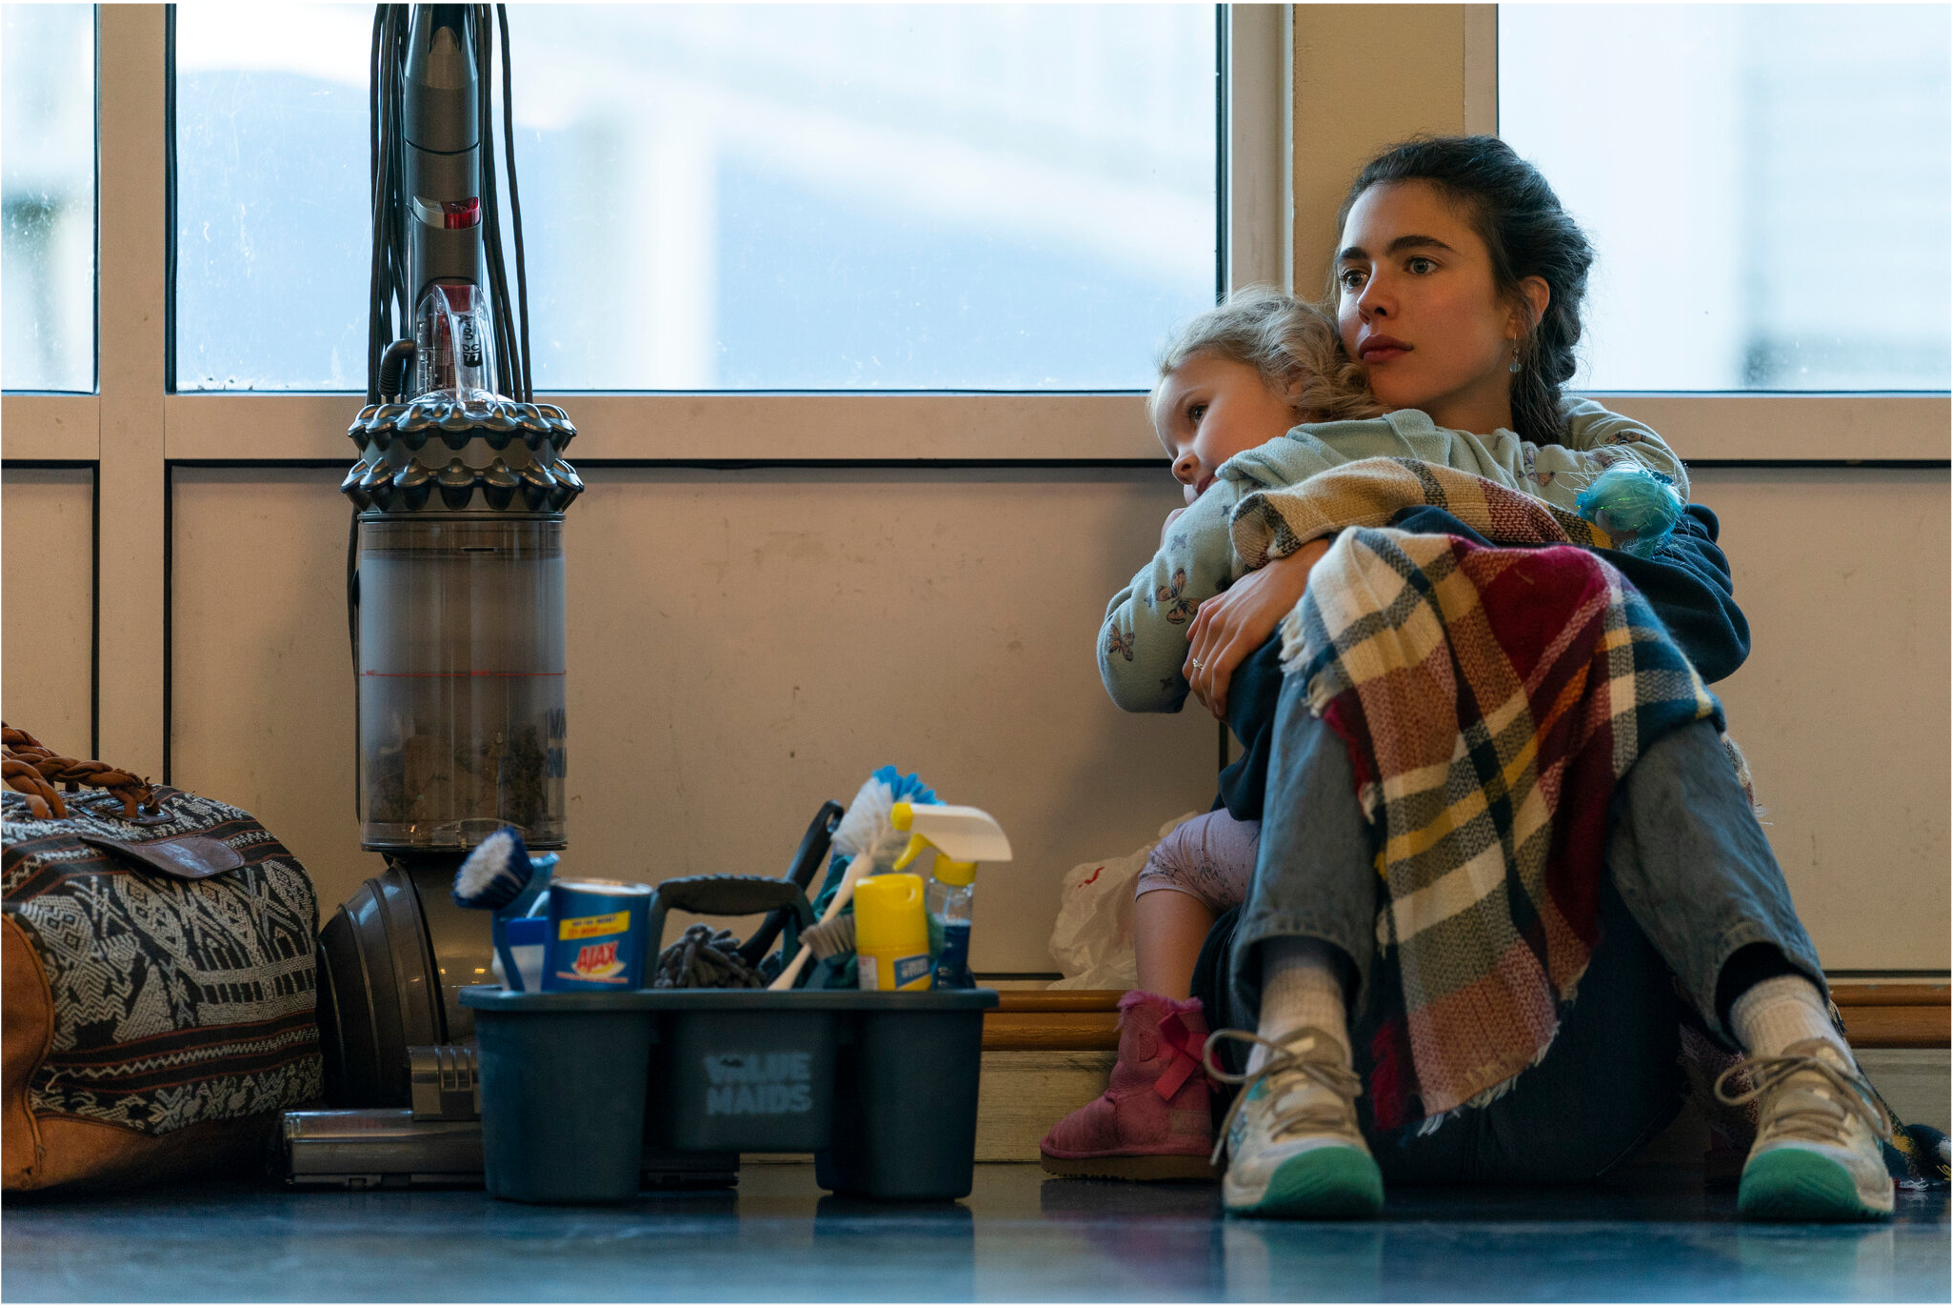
[319,4,583,1108]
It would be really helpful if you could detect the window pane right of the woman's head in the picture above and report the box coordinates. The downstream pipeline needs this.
[1500,4,1952,392]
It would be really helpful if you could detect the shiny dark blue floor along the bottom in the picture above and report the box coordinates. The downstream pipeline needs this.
[0,1165,1952,1304]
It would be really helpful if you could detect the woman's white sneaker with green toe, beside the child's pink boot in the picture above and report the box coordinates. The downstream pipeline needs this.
[1204,1026,1384,1218]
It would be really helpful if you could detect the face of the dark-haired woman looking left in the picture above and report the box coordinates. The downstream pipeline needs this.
[1337,182,1549,433]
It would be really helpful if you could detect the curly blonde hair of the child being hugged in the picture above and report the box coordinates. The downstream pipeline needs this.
[1149,286,1386,425]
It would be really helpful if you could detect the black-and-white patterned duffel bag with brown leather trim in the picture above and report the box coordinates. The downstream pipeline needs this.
[0,724,321,1191]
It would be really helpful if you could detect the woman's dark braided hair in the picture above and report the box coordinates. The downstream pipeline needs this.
[1333,137,1594,444]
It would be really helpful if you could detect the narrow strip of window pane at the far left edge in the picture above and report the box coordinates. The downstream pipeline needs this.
[0,4,96,392]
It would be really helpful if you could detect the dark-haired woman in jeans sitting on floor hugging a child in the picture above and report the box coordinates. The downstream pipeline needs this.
[1185,137,1893,1220]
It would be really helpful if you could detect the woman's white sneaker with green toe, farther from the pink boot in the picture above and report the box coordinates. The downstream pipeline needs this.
[1713,1040,1897,1222]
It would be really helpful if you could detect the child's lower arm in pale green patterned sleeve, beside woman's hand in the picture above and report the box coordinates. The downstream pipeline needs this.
[1095,478,1239,713]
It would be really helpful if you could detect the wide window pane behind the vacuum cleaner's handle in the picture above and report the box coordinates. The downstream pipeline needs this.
[178,4,1218,390]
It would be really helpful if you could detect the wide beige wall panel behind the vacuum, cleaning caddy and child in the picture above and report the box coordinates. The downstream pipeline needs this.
[170,468,1216,971]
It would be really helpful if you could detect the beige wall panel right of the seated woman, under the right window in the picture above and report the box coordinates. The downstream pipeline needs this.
[1694,468,1952,969]
